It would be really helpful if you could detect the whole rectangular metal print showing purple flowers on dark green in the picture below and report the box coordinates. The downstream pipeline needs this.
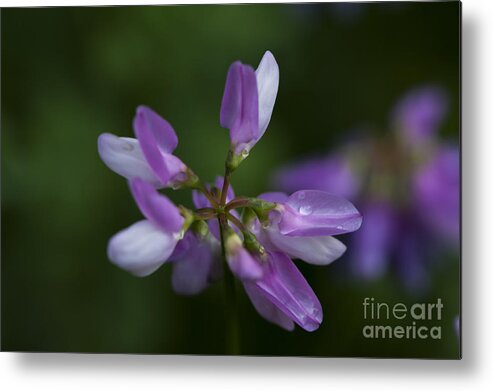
[1,1,461,359]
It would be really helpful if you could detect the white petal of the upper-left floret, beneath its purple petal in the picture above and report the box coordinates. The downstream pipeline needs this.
[98,133,162,187]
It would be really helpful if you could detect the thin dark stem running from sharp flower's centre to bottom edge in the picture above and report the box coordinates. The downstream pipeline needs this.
[218,214,240,355]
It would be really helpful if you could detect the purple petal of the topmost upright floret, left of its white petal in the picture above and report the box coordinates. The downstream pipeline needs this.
[220,61,260,152]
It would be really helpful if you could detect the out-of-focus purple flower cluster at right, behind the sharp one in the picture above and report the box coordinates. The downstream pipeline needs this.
[274,86,460,292]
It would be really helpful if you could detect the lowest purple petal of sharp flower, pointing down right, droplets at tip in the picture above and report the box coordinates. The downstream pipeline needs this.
[248,252,323,331]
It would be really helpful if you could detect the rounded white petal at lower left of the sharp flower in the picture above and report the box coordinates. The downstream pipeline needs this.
[108,220,177,277]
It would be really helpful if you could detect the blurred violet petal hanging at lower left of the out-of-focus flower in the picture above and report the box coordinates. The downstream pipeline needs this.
[350,202,398,279]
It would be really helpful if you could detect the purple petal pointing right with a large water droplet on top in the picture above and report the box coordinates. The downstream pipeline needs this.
[279,190,362,236]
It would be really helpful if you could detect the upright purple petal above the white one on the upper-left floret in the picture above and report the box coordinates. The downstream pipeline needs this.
[134,106,178,153]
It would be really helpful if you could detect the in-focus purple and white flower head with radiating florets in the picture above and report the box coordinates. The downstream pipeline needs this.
[98,51,362,331]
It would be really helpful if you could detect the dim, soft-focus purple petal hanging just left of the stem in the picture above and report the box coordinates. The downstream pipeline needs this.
[170,231,213,295]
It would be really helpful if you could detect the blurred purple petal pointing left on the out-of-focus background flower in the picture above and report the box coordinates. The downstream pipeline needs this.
[274,155,361,199]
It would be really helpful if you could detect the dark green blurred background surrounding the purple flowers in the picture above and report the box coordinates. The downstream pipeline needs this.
[1,2,460,358]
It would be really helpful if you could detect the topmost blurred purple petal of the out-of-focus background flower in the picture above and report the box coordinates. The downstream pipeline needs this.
[392,86,448,144]
